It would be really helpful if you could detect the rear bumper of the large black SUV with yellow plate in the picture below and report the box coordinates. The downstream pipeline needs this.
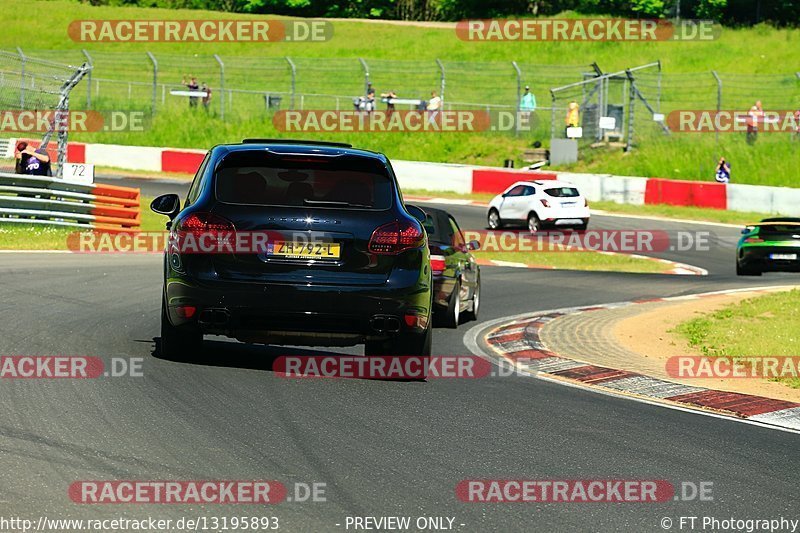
[166,276,431,346]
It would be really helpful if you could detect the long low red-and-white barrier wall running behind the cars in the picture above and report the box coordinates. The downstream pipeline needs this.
[6,143,800,216]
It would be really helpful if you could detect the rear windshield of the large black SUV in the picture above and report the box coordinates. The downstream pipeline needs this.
[215,150,392,210]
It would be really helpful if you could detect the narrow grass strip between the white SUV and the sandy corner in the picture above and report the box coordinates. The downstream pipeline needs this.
[475,251,667,274]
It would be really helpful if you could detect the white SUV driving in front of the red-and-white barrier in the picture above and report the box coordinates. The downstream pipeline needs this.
[487,180,589,233]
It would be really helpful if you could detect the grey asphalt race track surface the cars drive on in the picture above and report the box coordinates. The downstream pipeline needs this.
[0,174,800,532]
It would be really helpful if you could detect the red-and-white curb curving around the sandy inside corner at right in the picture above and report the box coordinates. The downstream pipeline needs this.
[464,285,800,433]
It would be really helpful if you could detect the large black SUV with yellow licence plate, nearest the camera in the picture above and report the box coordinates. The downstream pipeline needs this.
[151,139,432,358]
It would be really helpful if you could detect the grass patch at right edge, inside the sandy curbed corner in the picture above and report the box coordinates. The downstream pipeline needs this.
[673,289,800,389]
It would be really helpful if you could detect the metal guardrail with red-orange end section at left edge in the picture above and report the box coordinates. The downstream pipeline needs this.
[0,172,141,230]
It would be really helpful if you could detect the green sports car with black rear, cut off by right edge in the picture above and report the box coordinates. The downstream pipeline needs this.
[736,218,800,276]
